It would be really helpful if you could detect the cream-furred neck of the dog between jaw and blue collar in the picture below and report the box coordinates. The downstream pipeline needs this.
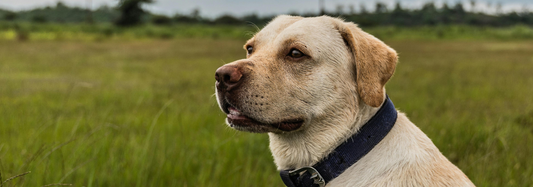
[269,101,380,170]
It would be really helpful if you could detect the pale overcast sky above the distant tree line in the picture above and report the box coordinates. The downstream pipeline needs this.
[0,0,533,17]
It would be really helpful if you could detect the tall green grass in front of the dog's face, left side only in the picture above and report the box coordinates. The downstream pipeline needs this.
[0,40,274,186]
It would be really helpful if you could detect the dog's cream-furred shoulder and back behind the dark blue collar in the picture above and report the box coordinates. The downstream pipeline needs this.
[328,112,474,186]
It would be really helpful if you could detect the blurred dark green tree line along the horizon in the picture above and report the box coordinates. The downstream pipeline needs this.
[0,0,533,27]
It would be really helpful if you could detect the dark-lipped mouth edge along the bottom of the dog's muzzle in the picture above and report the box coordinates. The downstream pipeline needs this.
[226,107,304,133]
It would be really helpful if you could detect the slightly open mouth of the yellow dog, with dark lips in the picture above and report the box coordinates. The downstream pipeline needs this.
[224,104,304,132]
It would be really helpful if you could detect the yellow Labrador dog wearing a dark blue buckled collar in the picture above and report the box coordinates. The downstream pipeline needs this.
[215,15,474,187]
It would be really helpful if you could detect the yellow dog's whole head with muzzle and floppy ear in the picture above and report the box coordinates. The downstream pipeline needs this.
[215,16,397,133]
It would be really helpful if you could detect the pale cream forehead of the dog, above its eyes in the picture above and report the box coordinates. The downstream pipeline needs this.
[254,16,336,45]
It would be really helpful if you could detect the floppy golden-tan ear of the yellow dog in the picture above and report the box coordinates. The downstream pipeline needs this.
[334,19,398,107]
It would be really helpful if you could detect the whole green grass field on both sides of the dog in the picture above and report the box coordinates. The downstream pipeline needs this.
[0,30,533,187]
